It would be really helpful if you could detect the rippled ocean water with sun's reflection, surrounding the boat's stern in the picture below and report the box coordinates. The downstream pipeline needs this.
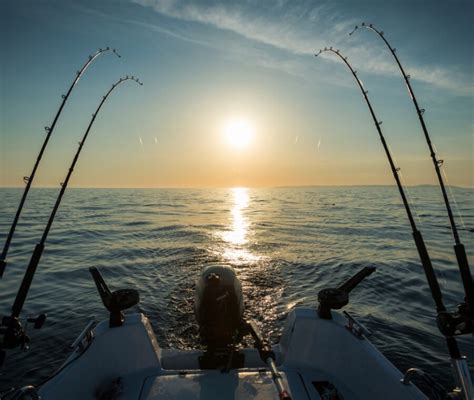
[0,186,474,390]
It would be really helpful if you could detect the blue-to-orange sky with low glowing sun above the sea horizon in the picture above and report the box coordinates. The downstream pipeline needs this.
[0,0,474,187]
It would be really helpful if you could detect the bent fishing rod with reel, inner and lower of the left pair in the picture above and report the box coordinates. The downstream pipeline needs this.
[0,75,143,365]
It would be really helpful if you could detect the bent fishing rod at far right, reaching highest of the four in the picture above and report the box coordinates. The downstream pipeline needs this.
[349,22,474,318]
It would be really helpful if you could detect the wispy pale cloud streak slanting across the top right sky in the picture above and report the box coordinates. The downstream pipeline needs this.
[132,0,474,96]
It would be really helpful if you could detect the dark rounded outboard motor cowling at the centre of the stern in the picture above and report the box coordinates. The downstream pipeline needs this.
[194,265,244,347]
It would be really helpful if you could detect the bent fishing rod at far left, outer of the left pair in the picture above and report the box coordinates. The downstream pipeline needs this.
[0,47,121,279]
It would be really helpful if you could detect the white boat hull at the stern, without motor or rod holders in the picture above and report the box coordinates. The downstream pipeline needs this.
[39,308,426,400]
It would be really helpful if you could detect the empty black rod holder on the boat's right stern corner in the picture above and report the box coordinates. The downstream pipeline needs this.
[318,267,375,319]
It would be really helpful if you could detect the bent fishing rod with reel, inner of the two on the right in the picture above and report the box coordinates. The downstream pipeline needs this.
[315,47,472,400]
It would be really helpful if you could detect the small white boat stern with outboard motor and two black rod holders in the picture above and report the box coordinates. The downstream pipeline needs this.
[5,265,427,400]
